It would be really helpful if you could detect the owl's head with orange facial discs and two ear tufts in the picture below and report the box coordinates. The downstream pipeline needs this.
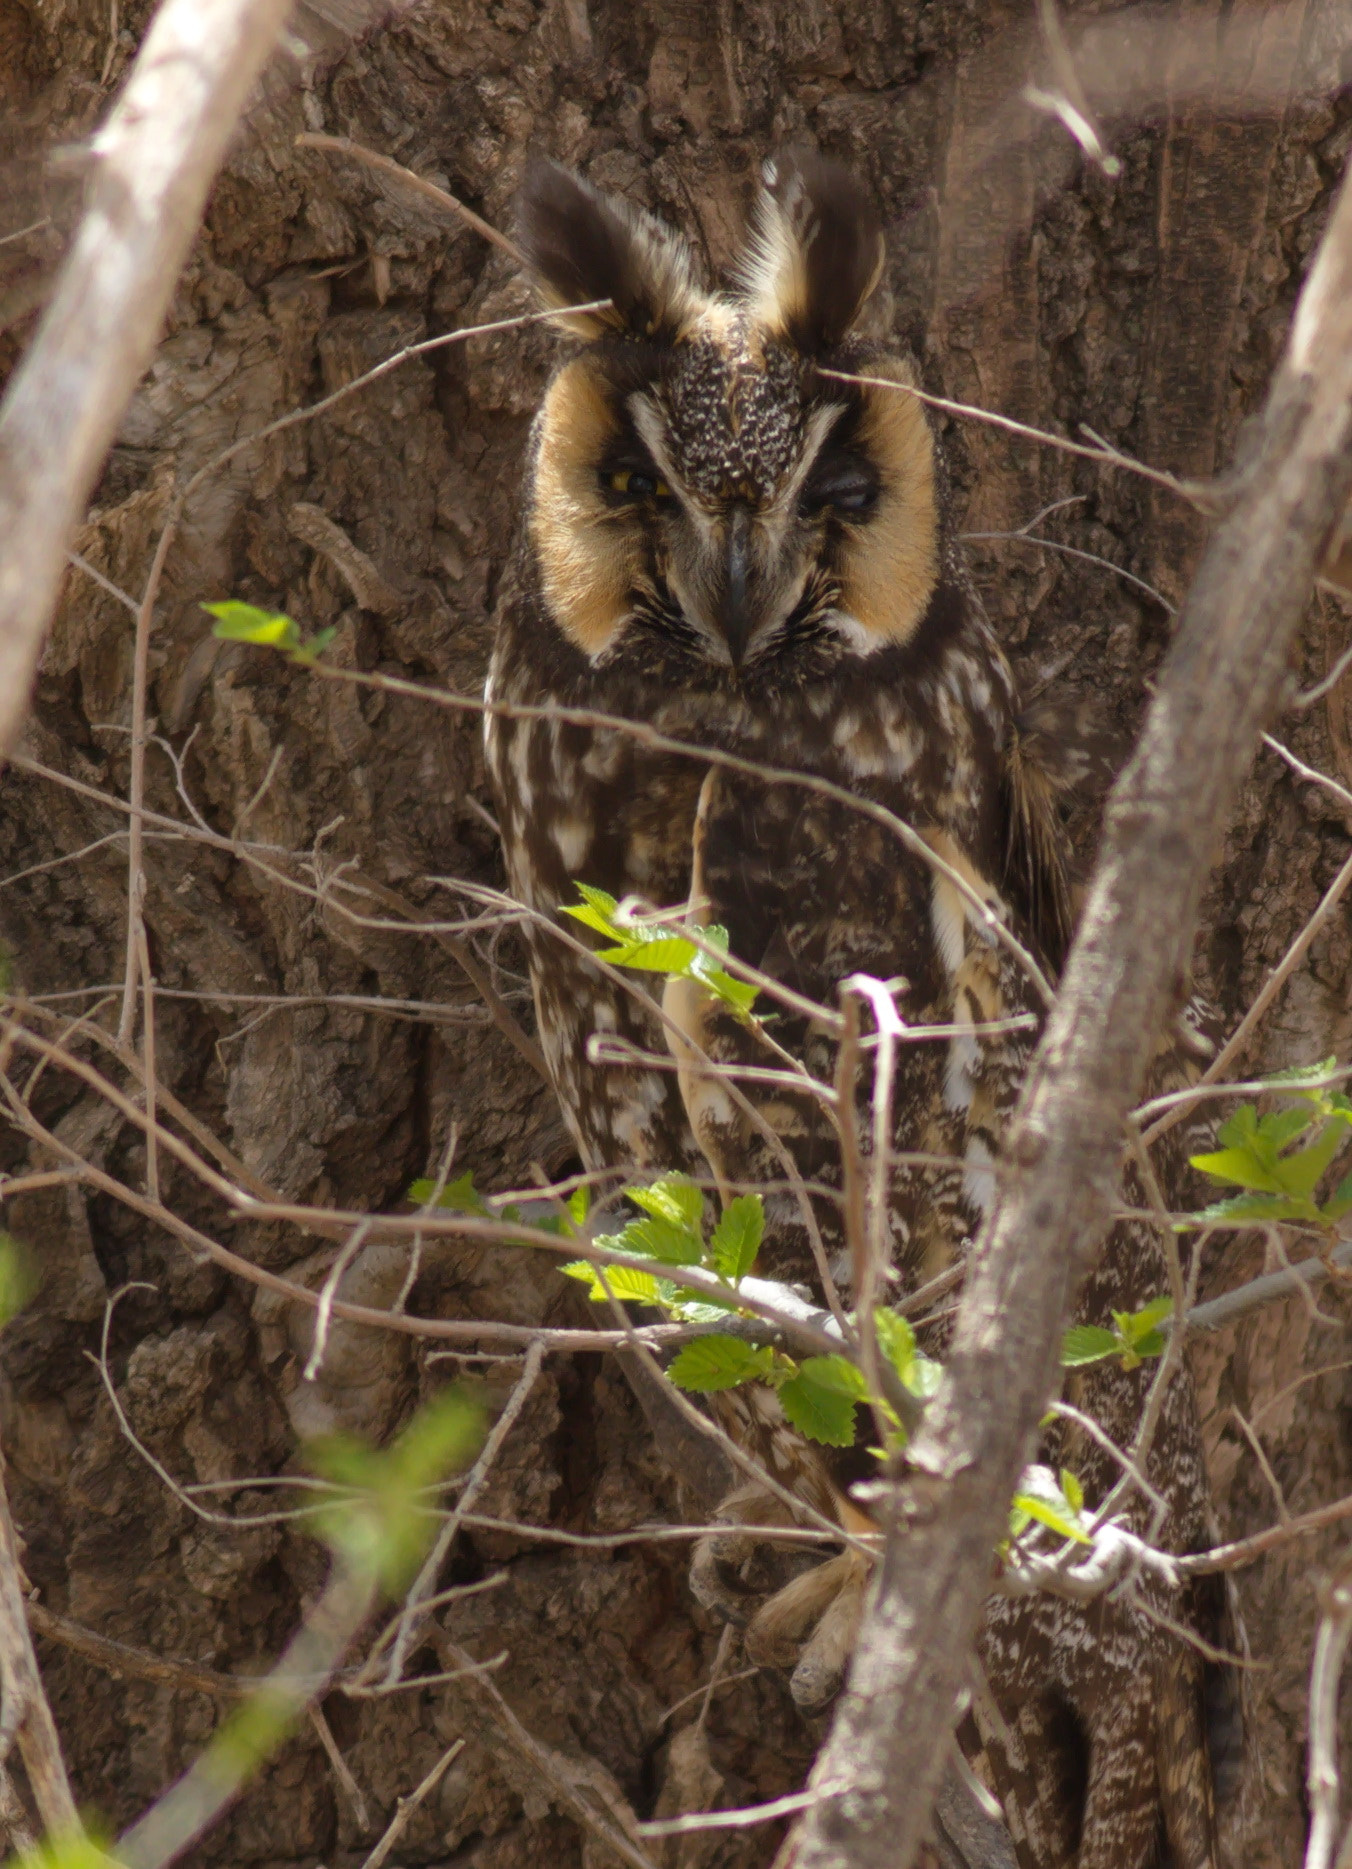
[520,157,939,669]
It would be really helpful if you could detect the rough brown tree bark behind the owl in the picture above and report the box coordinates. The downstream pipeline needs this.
[0,0,1352,1869]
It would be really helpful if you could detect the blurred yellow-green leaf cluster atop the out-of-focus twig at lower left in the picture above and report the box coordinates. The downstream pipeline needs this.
[305,1389,482,1596]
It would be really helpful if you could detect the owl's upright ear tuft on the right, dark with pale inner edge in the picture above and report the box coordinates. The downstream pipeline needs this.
[742,151,883,355]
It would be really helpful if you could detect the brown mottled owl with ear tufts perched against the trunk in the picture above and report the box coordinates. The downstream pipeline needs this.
[486,155,1234,1869]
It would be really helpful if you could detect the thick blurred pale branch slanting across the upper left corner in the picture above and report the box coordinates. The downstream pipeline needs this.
[0,0,290,766]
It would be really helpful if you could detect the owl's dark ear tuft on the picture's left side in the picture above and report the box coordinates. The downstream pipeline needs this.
[518,157,703,340]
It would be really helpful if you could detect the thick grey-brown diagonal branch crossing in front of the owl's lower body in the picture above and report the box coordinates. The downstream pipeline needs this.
[782,156,1352,1869]
